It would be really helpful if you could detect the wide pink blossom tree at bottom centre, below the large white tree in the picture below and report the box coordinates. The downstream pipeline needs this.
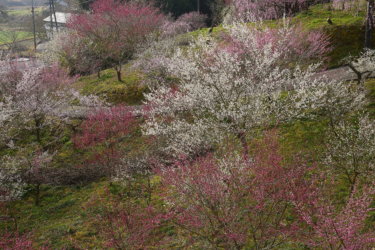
[158,133,309,249]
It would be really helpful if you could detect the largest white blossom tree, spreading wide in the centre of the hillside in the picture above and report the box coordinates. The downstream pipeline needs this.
[144,24,364,155]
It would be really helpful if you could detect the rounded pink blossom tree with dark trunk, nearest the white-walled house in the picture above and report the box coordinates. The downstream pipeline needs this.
[69,0,165,81]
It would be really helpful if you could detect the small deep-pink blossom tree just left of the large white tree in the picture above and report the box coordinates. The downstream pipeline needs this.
[73,106,138,181]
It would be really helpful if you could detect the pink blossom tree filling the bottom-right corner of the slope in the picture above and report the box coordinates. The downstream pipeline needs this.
[295,185,375,249]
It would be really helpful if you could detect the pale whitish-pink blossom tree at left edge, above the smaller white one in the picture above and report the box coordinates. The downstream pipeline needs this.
[0,61,101,147]
